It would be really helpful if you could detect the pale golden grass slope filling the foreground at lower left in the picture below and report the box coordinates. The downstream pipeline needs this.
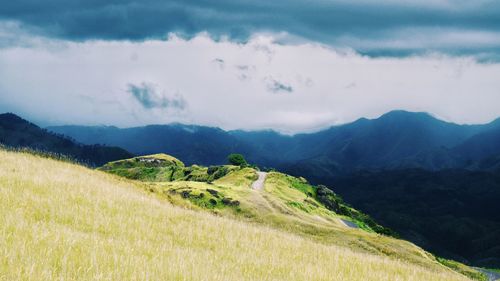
[0,150,472,280]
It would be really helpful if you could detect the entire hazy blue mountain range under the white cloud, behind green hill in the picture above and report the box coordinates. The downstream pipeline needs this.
[48,111,500,174]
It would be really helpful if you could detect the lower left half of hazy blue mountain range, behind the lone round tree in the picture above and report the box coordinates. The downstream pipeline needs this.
[48,124,254,165]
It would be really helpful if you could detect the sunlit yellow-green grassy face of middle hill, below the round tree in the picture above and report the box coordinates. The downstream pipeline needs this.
[143,163,448,268]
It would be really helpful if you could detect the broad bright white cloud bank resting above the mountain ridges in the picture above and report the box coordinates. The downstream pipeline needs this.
[0,32,500,133]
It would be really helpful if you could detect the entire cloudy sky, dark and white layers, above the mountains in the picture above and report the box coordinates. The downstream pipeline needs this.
[0,0,500,133]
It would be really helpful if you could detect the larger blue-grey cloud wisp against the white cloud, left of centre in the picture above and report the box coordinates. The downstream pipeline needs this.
[127,82,187,110]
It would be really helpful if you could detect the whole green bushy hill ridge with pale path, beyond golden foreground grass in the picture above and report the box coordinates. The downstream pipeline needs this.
[100,154,479,276]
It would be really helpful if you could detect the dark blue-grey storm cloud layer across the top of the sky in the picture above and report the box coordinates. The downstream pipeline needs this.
[0,0,500,56]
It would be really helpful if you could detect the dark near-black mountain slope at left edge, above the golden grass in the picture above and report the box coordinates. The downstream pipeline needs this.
[0,113,132,165]
